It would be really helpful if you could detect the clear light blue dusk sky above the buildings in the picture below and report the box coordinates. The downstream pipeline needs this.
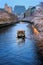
[0,0,43,8]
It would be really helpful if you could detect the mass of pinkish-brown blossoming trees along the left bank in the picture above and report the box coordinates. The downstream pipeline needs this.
[0,8,18,22]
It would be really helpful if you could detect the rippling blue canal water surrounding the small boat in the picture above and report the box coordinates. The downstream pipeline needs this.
[0,23,41,65]
